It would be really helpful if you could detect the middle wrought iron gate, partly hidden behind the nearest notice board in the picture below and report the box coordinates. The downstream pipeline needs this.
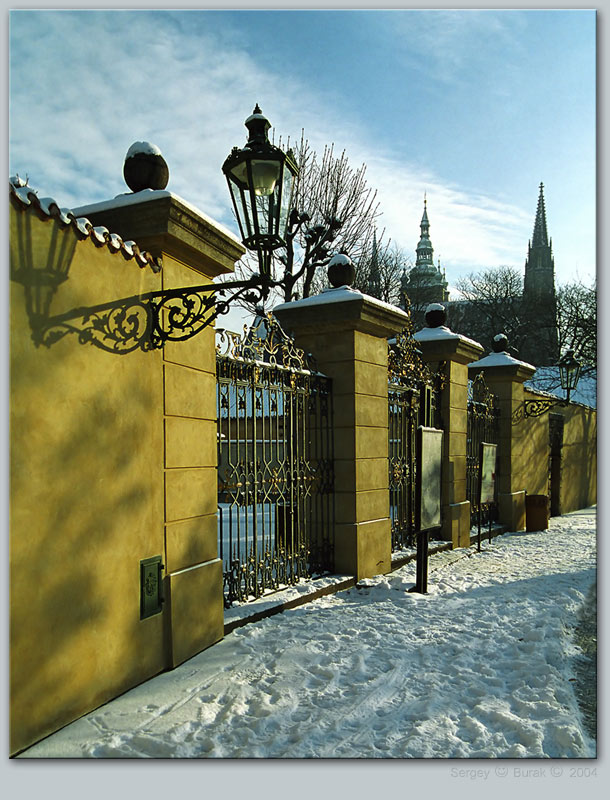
[388,322,444,551]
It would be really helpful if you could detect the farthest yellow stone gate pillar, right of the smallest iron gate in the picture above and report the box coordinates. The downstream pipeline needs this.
[468,337,536,531]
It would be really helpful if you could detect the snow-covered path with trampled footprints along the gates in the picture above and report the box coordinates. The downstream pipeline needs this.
[22,511,596,758]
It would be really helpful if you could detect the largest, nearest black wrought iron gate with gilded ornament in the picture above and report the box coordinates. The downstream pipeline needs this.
[216,315,333,606]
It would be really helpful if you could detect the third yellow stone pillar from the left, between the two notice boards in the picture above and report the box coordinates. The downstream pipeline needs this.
[414,318,483,548]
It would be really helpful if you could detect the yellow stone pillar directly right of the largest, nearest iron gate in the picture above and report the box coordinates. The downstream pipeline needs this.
[274,286,408,579]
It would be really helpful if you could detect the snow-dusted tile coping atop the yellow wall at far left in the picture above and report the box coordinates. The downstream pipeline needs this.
[9,176,161,272]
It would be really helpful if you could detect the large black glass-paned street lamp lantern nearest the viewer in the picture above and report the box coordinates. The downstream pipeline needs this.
[222,104,298,279]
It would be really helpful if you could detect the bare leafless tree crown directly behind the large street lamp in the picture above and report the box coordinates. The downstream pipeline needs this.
[226,134,379,310]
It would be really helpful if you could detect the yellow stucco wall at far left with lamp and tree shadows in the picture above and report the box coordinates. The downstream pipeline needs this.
[10,208,166,752]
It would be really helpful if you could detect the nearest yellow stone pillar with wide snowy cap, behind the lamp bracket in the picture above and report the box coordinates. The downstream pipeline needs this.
[77,190,244,666]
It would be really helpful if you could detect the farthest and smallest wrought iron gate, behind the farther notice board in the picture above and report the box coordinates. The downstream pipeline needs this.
[466,373,499,526]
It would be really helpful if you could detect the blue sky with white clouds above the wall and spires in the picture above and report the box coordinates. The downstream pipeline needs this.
[9,9,596,296]
